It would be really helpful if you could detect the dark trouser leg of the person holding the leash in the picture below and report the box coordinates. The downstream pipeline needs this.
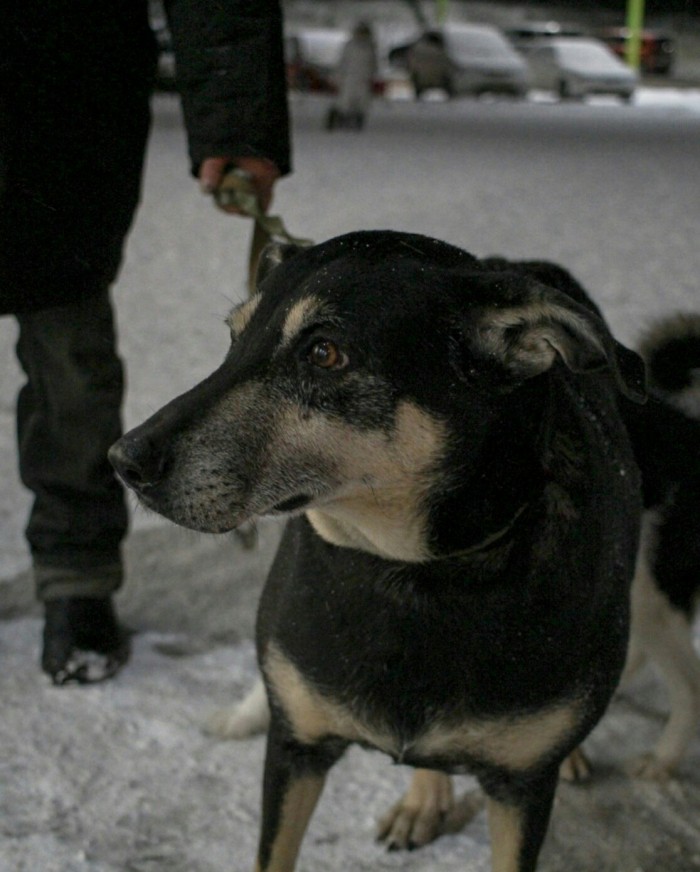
[17,290,127,600]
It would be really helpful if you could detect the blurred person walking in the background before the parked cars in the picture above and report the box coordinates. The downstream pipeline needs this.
[326,21,377,130]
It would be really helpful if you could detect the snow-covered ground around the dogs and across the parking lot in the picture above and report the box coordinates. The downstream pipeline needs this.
[0,89,700,872]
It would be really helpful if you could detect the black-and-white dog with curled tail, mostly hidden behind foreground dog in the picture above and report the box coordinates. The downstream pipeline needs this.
[206,286,700,784]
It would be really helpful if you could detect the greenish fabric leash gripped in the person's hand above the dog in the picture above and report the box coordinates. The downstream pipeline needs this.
[214,167,313,296]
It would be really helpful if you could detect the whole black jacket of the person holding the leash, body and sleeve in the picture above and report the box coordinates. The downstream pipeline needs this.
[0,0,290,313]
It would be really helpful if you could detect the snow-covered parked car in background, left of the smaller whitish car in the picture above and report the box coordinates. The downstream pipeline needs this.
[389,24,529,97]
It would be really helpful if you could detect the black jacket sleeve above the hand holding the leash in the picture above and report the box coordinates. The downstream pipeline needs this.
[166,0,291,175]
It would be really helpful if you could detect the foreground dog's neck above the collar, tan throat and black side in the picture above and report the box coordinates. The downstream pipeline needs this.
[306,386,548,563]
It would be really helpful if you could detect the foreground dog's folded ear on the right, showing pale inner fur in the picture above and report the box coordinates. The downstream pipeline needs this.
[454,278,646,403]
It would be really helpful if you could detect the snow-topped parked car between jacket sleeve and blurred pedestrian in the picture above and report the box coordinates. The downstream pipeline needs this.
[284,27,350,94]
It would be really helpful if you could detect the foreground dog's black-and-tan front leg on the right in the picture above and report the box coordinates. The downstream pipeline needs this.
[486,768,558,872]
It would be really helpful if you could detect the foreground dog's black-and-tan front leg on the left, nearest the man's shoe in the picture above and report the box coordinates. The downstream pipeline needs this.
[255,714,345,872]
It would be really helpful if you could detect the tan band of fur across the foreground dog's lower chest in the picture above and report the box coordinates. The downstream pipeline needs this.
[265,645,580,772]
